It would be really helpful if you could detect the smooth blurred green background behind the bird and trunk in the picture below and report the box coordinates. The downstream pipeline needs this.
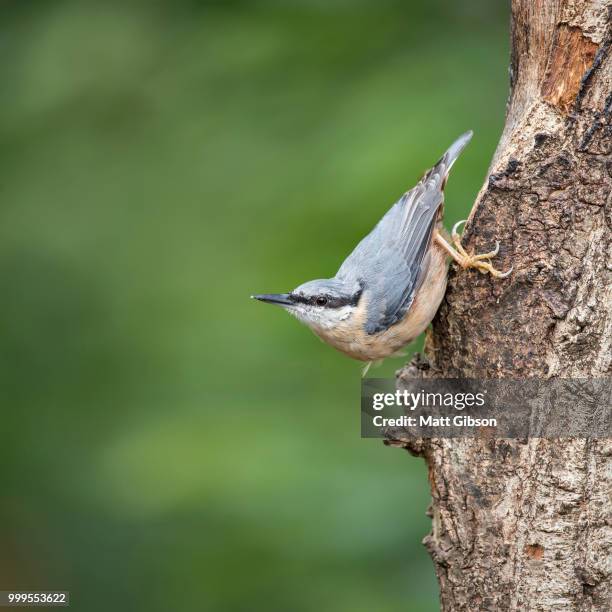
[0,0,508,612]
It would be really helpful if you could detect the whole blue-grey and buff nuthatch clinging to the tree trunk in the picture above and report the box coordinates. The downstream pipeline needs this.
[252,132,512,373]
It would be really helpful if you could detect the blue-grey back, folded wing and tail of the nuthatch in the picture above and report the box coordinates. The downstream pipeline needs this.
[336,132,472,334]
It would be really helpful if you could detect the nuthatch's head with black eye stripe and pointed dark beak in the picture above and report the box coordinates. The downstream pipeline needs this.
[252,278,363,331]
